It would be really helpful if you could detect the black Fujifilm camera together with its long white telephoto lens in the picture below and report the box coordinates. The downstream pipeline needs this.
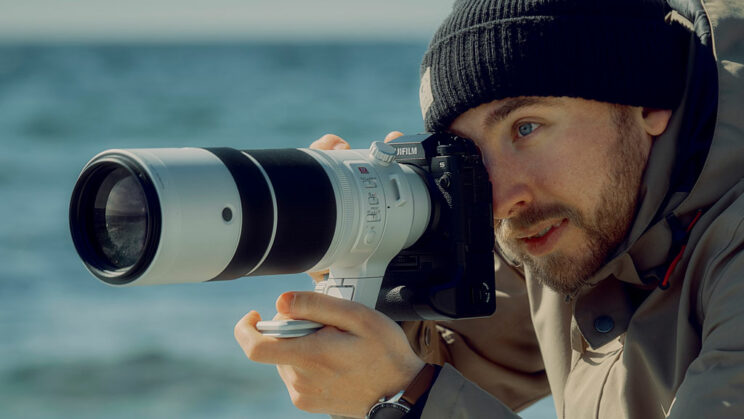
[70,133,495,320]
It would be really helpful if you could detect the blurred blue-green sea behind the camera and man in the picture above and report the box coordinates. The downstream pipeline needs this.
[0,42,555,419]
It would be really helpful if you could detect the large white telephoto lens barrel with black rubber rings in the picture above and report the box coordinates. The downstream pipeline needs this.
[70,145,431,292]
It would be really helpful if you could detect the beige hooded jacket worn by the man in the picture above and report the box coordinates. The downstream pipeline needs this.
[404,0,744,419]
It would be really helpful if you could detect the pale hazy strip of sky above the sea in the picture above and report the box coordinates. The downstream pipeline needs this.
[0,0,452,44]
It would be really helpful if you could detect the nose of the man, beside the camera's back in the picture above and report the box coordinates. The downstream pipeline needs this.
[484,156,534,219]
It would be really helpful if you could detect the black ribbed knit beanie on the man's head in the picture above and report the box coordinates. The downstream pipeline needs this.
[420,0,690,131]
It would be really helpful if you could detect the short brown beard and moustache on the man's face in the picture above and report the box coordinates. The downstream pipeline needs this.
[495,106,648,296]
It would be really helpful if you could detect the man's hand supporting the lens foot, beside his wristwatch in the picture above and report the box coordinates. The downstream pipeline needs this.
[235,292,424,418]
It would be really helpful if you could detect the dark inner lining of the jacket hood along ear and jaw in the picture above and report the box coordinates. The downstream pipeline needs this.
[588,0,724,285]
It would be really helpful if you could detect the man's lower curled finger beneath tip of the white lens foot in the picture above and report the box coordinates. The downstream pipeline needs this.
[235,311,312,365]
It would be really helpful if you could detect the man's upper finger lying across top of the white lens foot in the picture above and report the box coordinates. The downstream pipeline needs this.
[276,292,394,336]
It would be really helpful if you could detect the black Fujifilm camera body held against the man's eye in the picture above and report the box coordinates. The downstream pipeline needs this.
[376,133,496,320]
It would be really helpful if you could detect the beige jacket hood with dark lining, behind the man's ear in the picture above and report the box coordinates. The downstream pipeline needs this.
[589,0,744,284]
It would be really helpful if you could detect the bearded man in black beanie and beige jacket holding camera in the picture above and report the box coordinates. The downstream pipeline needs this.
[236,0,744,418]
